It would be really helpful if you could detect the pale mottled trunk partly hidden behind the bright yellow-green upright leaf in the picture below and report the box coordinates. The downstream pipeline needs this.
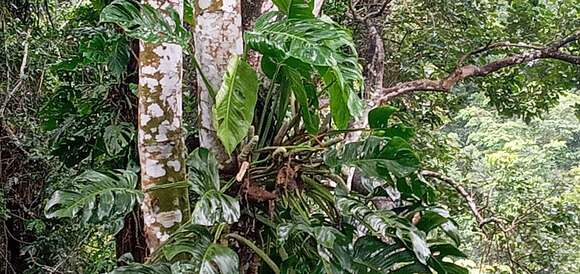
[194,0,244,167]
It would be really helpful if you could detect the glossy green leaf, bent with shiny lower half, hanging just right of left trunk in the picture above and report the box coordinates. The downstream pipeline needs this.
[187,148,240,226]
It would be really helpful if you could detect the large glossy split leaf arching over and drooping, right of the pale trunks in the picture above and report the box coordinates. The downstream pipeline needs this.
[245,15,363,128]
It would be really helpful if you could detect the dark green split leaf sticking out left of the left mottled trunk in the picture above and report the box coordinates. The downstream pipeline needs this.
[45,170,143,233]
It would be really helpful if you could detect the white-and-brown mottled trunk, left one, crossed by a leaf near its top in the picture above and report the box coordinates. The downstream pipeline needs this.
[138,0,190,251]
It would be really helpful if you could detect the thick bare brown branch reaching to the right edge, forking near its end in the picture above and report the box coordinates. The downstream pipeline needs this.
[378,31,580,103]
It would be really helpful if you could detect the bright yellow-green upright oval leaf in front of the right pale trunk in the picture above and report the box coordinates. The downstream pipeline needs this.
[213,55,258,154]
